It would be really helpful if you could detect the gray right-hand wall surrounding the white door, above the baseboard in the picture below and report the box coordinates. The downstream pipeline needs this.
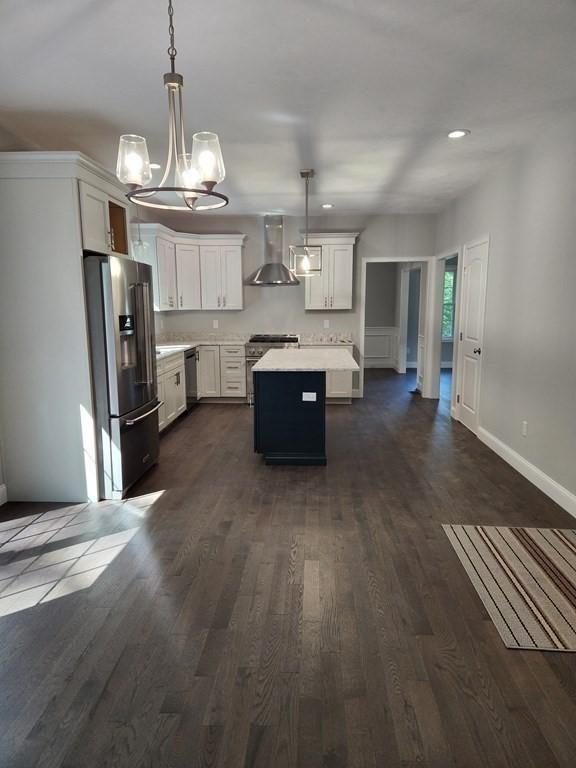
[436,120,576,493]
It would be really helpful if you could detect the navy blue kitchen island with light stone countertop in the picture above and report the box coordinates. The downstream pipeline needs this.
[252,348,359,465]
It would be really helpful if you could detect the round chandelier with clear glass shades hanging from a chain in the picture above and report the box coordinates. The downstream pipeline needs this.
[116,0,229,211]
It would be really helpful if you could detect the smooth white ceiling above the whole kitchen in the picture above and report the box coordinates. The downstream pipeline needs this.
[0,0,576,214]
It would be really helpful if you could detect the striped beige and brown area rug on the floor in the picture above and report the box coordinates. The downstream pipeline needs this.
[442,525,576,651]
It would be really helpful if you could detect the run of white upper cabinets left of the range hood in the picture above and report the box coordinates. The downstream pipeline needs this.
[132,224,244,311]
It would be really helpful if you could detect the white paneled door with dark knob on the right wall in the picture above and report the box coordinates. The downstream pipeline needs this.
[458,240,489,434]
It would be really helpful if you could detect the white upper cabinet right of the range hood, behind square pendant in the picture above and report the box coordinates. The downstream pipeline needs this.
[305,232,358,310]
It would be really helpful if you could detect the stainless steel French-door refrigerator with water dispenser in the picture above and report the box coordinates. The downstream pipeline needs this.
[84,252,161,499]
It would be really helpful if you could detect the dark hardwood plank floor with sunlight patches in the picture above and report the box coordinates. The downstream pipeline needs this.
[0,371,576,768]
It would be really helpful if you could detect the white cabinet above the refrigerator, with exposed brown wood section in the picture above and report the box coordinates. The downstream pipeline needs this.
[79,181,128,256]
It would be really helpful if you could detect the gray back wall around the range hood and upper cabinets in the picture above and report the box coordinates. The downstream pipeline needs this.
[143,212,435,343]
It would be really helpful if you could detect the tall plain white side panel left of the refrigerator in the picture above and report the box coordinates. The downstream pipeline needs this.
[0,178,95,501]
